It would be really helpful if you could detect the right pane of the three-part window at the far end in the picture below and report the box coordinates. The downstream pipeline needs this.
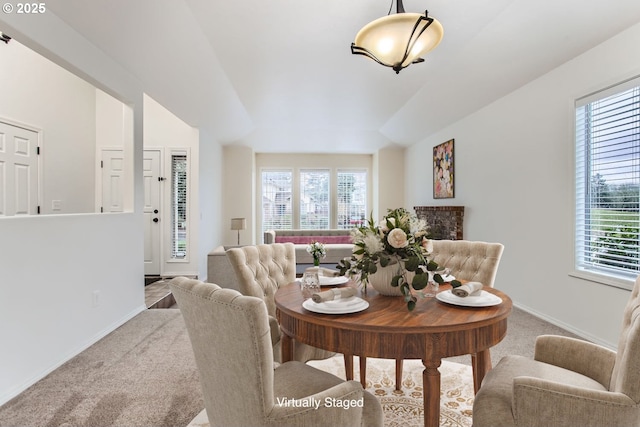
[337,171,367,230]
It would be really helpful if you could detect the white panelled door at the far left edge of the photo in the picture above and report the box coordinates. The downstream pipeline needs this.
[0,122,38,216]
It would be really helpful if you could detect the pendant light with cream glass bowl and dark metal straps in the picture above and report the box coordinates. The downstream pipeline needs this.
[351,0,444,74]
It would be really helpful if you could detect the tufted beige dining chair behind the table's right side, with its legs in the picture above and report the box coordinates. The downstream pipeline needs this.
[360,240,504,391]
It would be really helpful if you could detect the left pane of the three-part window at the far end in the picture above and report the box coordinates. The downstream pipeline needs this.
[262,170,293,233]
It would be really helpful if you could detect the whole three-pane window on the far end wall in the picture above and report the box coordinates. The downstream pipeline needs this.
[261,168,367,233]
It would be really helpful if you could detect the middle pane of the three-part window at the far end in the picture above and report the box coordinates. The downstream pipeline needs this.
[300,169,330,230]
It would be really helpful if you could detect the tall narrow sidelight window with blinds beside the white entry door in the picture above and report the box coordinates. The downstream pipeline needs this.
[171,154,187,259]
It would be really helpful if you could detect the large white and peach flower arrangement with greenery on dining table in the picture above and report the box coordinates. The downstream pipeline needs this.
[338,208,460,310]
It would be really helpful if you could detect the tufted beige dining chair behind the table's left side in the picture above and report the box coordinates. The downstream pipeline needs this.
[227,243,335,362]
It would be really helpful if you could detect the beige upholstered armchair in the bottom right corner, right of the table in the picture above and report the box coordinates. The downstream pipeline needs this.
[473,277,640,427]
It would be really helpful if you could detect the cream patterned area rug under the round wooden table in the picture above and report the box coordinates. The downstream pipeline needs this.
[188,355,473,427]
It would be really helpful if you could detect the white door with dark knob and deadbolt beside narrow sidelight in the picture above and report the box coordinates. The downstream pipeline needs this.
[143,150,162,275]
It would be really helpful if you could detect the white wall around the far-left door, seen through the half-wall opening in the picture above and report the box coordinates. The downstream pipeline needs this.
[0,40,96,214]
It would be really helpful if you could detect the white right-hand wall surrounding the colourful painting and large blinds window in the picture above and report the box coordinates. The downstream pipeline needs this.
[405,20,640,347]
